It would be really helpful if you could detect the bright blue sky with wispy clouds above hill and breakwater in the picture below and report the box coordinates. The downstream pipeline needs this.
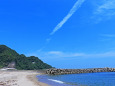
[0,0,115,68]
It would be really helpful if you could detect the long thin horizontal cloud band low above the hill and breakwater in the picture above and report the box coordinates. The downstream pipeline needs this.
[26,51,115,59]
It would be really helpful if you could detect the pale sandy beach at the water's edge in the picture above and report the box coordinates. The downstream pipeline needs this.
[0,71,49,86]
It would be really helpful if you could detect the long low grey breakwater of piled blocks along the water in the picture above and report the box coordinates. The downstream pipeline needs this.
[46,68,115,75]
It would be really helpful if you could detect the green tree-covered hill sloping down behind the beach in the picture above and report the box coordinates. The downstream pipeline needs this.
[0,45,52,70]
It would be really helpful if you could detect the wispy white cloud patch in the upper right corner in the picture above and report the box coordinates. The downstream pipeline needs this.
[94,0,115,20]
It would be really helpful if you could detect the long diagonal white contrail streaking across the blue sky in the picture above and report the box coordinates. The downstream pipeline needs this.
[50,0,85,35]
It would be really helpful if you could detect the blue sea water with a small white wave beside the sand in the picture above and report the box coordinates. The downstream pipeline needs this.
[37,72,115,86]
